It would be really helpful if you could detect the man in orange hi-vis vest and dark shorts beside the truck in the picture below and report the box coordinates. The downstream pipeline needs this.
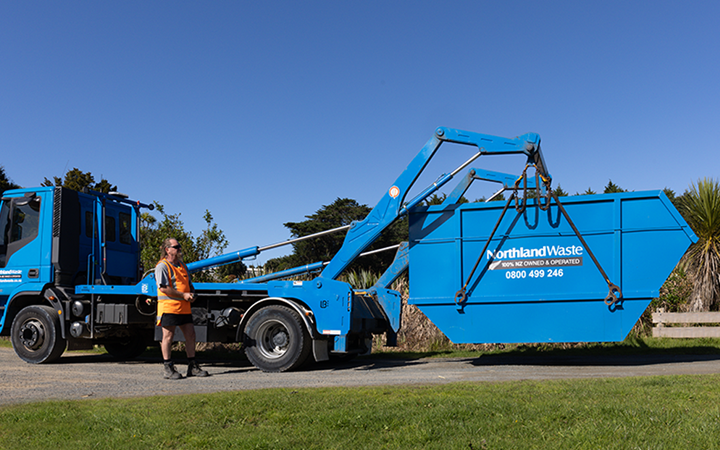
[155,238,208,380]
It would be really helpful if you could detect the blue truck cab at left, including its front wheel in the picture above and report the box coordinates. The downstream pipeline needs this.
[0,187,147,362]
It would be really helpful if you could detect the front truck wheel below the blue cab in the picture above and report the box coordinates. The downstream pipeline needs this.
[10,306,67,364]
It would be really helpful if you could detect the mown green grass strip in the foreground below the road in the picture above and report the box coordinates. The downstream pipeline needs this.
[0,375,720,449]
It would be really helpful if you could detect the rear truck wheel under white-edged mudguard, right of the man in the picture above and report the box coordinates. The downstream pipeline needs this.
[243,305,311,372]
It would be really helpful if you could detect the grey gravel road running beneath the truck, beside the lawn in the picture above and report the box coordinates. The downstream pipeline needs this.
[0,348,720,405]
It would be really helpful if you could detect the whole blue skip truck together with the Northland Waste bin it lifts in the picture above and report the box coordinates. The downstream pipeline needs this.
[0,127,697,372]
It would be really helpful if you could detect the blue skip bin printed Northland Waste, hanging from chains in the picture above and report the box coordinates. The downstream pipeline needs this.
[408,191,697,344]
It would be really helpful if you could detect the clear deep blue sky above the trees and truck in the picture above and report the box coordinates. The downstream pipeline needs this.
[0,1,720,263]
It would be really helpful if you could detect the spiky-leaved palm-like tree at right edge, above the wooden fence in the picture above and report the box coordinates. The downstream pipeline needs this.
[679,178,720,311]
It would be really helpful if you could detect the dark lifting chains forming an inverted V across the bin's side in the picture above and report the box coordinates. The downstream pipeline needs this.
[455,164,622,306]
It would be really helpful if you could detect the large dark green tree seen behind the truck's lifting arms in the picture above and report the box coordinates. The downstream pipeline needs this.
[266,198,408,273]
